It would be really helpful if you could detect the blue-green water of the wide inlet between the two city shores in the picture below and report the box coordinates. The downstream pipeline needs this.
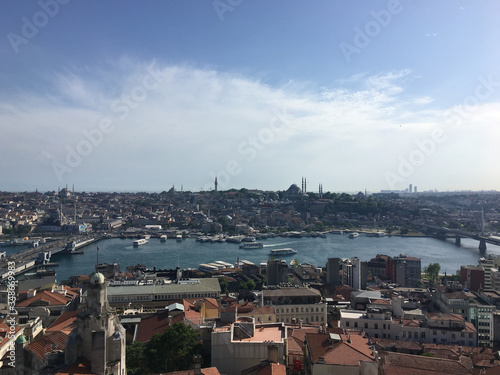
[3,234,500,281]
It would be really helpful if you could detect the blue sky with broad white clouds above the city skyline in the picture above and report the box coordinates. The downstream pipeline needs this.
[0,0,500,192]
